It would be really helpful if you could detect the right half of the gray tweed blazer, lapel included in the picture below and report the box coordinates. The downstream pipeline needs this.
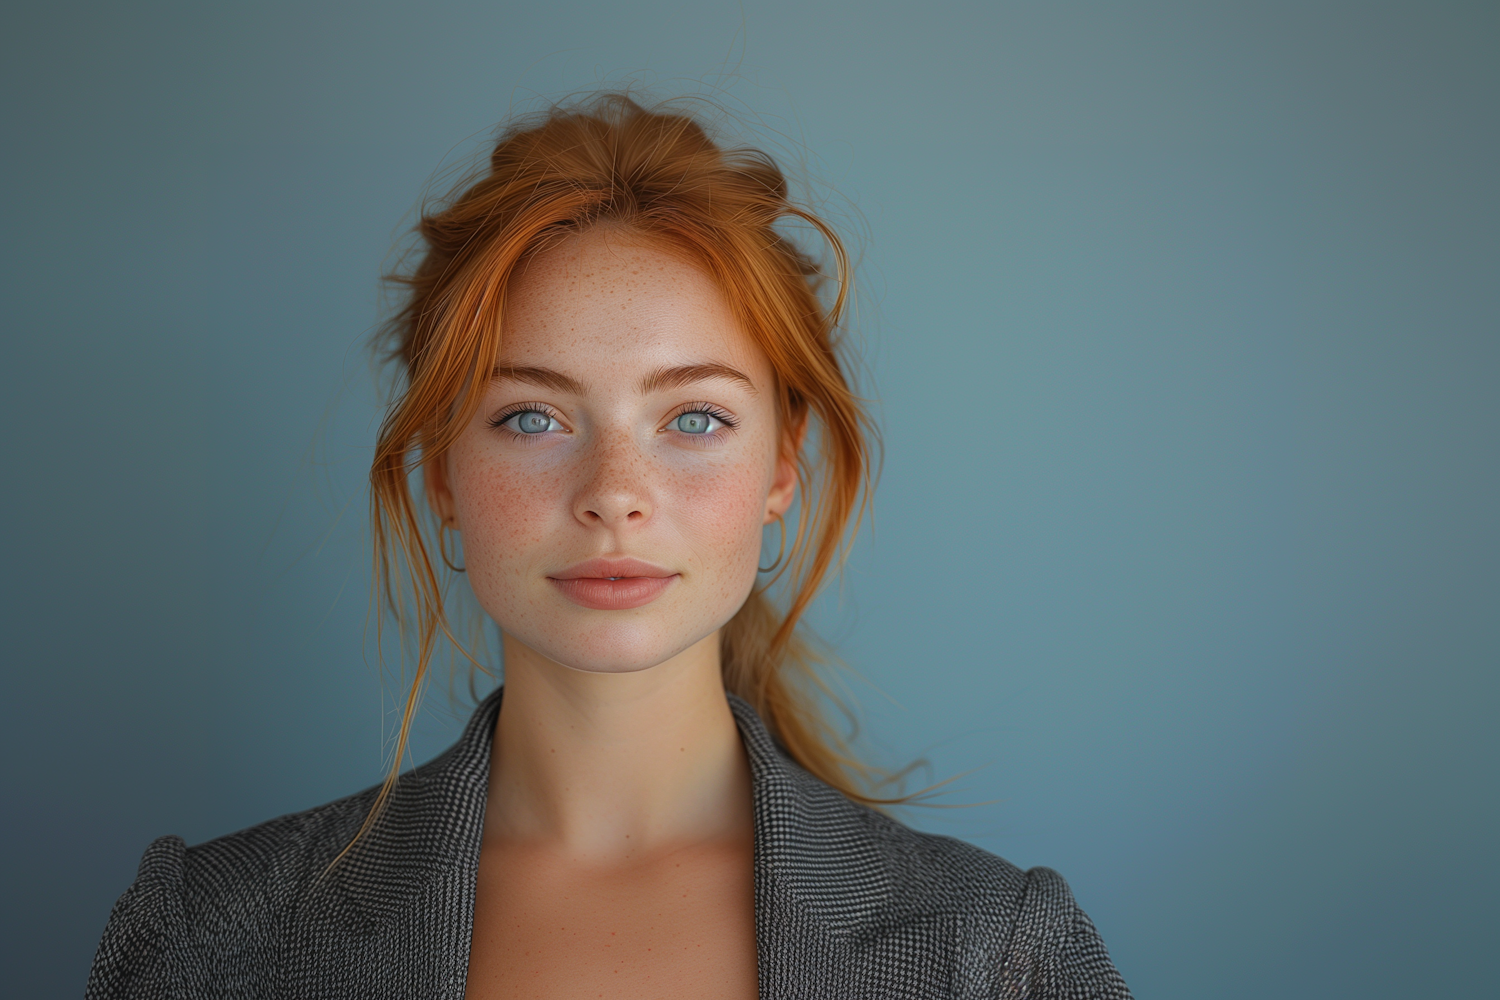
[729,694,1130,1000]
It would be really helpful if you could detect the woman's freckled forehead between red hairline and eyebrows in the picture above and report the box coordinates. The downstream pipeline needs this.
[500,226,770,381]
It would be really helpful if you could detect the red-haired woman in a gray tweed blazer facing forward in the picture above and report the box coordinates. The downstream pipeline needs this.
[89,96,1128,1000]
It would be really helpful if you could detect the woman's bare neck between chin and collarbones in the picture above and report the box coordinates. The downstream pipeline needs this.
[485,633,752,861]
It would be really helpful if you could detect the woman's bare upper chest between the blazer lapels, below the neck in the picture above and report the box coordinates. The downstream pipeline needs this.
[467,844,758,1000]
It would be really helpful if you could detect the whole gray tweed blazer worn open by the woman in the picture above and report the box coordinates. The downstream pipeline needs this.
[87,691,1130,1000]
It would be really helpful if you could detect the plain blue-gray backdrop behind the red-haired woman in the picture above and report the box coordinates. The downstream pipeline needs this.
[0,0,1500,999]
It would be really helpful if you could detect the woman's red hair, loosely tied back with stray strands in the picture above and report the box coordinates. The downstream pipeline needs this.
[362,94,876,832]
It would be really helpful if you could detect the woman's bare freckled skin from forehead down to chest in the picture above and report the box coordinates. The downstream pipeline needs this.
[428,226,800,1000]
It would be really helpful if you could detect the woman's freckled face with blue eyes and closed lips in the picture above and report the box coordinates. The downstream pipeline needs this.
[434,228,795,672]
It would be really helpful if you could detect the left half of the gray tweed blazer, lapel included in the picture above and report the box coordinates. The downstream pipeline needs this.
[87,693,500,1000]
